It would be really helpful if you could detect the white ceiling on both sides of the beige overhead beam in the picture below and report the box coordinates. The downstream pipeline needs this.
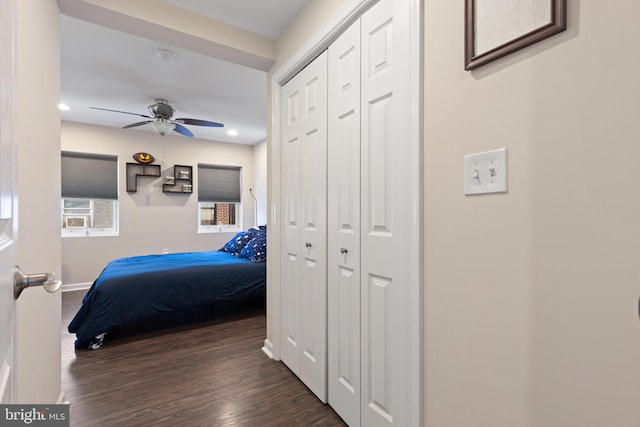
[60,0,310,144]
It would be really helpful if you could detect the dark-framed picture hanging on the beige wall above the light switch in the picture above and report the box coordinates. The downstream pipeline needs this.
[464,0,567,70]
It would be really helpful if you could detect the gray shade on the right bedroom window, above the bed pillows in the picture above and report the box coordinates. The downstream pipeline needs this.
[198,164,240,203]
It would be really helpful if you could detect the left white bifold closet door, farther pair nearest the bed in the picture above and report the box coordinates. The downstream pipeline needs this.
[281,51,327,402]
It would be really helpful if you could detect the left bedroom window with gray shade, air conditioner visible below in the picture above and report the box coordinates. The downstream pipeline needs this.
[61,151,118,237]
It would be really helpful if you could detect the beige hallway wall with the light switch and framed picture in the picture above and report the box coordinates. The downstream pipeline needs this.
[424,0,640,427]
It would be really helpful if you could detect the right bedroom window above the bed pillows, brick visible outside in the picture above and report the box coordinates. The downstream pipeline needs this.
[198,164,242,233]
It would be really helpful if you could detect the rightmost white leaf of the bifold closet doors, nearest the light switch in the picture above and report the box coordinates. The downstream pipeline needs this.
[361,0,407,426]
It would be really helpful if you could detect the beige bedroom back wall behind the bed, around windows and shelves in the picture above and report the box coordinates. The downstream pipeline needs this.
[57,122,266,284]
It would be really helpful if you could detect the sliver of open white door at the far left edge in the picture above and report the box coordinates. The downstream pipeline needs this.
[0,1,17,403]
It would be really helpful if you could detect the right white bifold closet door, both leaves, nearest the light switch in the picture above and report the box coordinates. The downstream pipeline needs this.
[327,0,418,427]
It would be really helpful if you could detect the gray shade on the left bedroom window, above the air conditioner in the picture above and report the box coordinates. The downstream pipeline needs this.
[62,151,118,200]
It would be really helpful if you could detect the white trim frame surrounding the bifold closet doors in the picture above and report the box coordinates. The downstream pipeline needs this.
[262,0,424,425]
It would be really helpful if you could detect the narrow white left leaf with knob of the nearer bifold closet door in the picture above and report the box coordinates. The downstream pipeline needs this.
[327,16,360,426]
